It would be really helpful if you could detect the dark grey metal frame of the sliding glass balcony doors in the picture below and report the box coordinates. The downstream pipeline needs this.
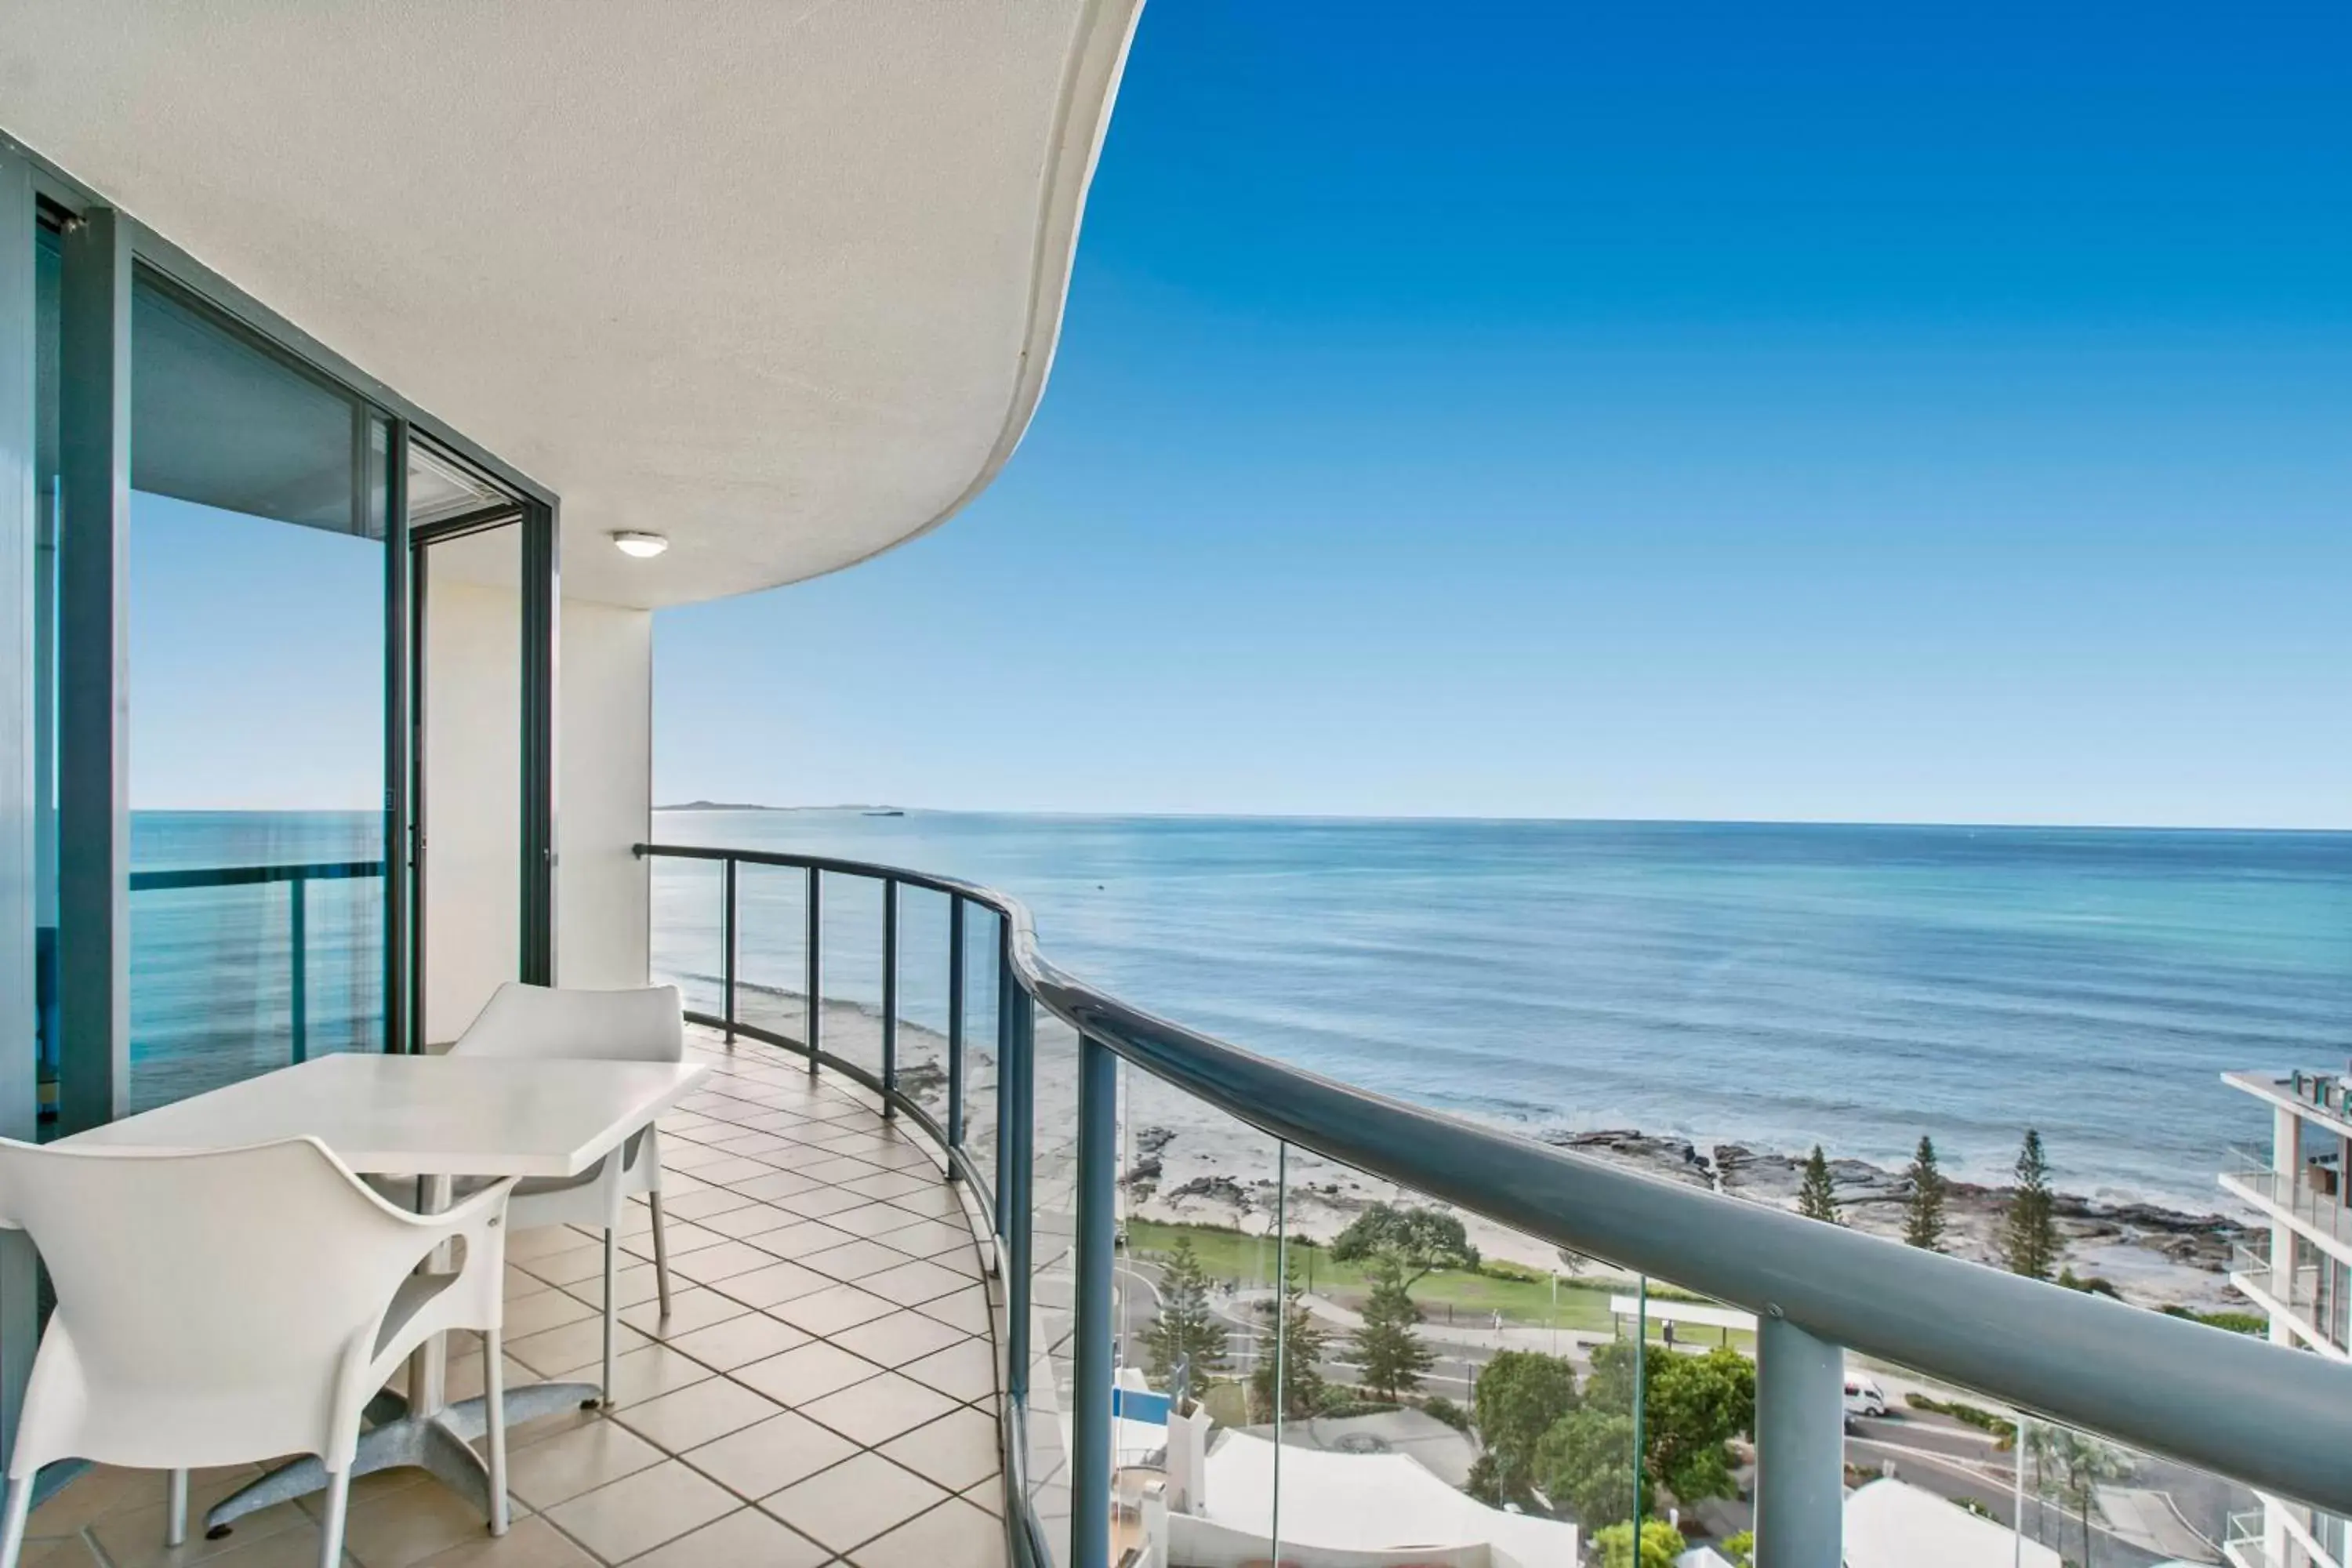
[0,136,560,1457]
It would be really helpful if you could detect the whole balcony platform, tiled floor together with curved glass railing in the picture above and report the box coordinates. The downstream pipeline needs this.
[13,846,2352,1568]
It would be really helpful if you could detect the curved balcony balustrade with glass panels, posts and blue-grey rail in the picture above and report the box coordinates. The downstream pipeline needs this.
[597,846,2352,1568]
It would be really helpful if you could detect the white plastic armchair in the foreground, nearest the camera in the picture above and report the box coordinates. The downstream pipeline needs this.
[0,1138,513,1568]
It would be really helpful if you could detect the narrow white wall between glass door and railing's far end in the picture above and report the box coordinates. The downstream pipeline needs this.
[555,600,654,987]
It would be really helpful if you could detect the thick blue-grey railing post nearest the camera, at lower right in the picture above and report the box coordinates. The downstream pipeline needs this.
[1757,1307,1846,1568]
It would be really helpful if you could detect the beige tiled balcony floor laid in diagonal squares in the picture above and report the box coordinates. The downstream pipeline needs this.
[24,1029,1004,1568]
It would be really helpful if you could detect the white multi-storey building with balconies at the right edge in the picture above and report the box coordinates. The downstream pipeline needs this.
[2220,1069,2352,1568]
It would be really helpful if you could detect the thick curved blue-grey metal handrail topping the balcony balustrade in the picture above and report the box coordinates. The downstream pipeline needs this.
[637,844,2352,1552]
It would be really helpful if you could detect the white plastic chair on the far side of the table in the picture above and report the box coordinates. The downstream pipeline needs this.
[452,980,687,1401]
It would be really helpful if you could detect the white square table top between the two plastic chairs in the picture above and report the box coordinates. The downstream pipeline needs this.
[56,1053,710,1178]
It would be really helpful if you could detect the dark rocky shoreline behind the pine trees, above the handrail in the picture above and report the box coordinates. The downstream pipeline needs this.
[1543,1128,2251,1312]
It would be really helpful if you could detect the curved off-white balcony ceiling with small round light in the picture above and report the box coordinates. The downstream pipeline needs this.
[0,0,1141,607]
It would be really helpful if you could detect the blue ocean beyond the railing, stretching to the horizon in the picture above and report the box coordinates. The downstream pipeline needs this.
[654,808,2352,1210]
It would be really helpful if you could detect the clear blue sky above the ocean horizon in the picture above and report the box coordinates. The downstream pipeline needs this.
[656,0,2352,825]
